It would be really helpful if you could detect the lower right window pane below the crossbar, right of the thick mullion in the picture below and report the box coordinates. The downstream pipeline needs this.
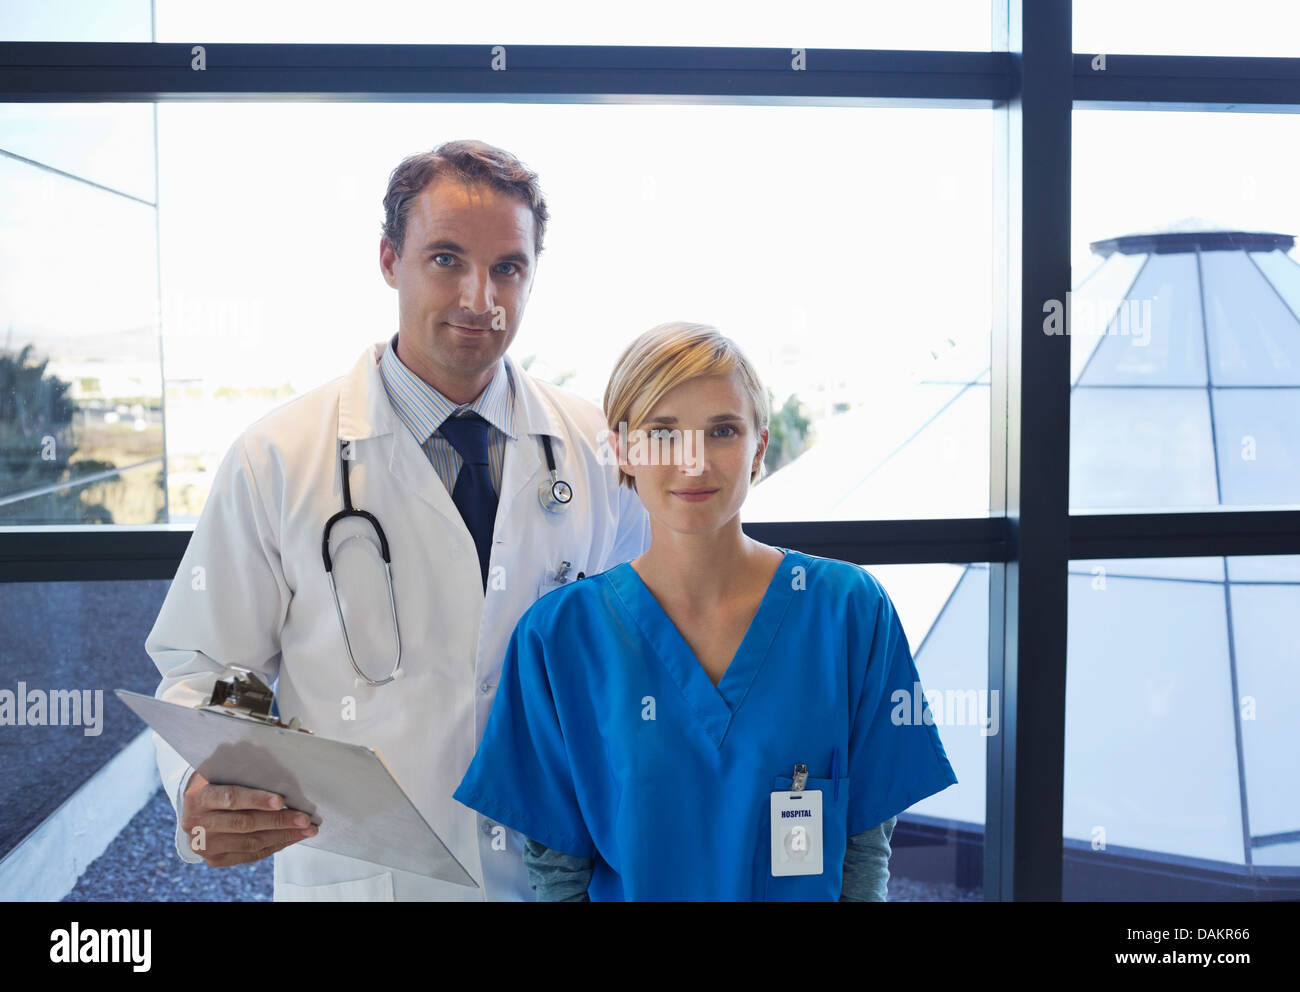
[1063,558,1300,900]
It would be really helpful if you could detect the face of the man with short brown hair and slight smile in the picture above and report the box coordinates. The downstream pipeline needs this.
[380,179,537,392]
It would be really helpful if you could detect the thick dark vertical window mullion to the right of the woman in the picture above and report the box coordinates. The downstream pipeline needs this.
[984,0,1073,901]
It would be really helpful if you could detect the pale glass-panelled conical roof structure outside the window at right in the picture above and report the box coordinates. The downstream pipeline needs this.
[745,231,1300,867]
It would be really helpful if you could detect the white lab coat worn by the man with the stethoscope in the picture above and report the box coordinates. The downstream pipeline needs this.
[146,343,650,901]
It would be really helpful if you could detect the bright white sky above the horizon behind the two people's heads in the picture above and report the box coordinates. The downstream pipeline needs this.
[147,96,992,398]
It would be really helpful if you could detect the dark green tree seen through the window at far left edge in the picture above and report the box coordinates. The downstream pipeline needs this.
[0,345,116,524]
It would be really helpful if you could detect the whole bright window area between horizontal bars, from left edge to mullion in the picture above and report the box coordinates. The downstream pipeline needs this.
[0,104,992,524]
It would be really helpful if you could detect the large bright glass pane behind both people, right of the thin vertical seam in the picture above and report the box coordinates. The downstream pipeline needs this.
[149,104,992,523]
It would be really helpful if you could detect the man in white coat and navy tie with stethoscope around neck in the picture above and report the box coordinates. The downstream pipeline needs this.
[146,140,650,901]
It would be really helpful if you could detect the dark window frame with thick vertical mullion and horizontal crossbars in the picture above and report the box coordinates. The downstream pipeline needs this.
[0,0,1300,901]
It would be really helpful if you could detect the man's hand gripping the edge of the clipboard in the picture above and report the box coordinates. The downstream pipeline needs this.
[181,772,316,868]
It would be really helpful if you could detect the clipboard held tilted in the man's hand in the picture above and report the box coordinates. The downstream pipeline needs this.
[114,689,478,888]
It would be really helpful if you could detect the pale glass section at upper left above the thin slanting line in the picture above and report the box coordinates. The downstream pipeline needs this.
[0,103,153,203]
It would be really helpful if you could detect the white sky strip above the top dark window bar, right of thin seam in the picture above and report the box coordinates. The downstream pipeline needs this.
[157,0,1300,56]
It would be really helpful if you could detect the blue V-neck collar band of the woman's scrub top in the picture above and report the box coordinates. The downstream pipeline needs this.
[603,547,806,748]
